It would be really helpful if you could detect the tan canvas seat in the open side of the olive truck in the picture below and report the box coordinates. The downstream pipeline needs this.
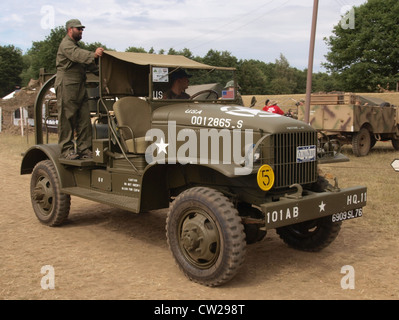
[114,96,152,154]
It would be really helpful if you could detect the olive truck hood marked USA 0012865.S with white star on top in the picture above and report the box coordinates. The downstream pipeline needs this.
[153,103,314,134]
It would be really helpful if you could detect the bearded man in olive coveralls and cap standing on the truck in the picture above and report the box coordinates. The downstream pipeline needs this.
[54,19,104,160]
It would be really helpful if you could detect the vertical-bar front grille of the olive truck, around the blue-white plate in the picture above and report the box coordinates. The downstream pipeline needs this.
[272,132,317,188]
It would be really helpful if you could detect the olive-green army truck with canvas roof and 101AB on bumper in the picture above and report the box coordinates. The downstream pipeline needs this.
[21,51,367,286]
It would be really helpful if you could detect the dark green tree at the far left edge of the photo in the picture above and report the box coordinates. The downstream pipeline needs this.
[0,45,23,98]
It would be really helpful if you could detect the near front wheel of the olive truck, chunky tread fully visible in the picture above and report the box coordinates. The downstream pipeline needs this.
[166,187,246,287]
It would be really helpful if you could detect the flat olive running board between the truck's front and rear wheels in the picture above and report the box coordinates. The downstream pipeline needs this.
[61,187,140,213]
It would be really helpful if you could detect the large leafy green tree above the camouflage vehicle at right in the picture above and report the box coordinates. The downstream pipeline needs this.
[324,0,399,92]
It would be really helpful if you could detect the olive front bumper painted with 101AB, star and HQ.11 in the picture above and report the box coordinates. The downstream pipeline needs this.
[261,187,367,229]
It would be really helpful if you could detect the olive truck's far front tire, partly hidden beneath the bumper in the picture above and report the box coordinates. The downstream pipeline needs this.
[276,216,342,252]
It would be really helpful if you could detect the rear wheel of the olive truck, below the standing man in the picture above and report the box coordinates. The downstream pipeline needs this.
[30,160,71,227]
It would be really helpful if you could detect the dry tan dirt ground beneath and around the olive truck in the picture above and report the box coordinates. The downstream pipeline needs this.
[0,136,399,300]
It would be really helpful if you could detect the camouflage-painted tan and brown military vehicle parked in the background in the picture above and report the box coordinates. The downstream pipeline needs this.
[298,93,399,157]
